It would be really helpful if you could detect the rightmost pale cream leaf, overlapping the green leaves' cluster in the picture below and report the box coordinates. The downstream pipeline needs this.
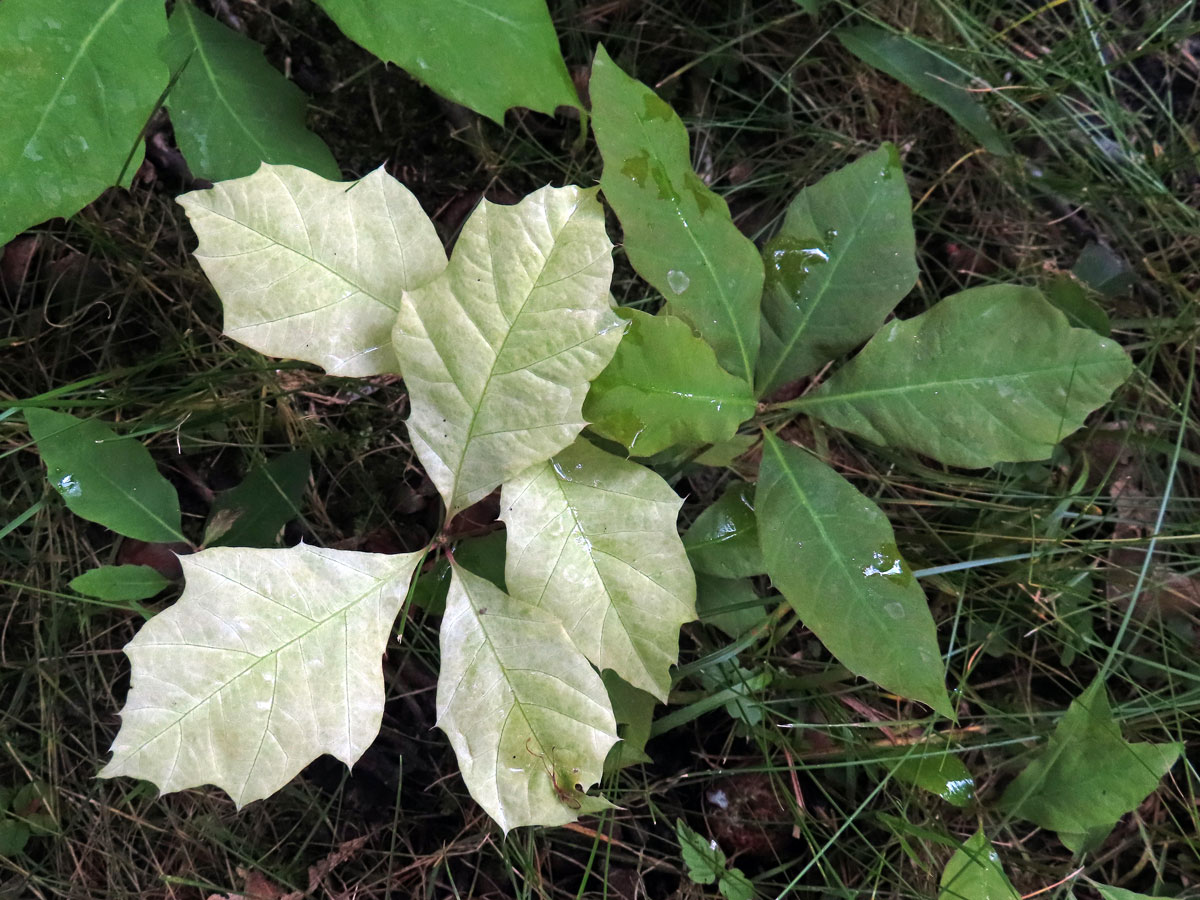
[500,440,696,701]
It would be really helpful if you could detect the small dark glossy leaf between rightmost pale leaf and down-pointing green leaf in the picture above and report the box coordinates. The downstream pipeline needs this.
[683,481,767,578]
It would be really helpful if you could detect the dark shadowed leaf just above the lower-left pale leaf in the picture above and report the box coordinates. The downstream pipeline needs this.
[204,450,310,547]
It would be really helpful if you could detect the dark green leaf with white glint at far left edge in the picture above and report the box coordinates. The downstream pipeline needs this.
[24,408,186,542]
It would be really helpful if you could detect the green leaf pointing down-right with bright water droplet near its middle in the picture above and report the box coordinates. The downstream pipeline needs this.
[755,434,953,715]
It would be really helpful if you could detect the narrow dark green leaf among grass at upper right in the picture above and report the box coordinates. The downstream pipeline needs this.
[834,25,1012,156]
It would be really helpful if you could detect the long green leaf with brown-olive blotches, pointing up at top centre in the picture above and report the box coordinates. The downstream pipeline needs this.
[590,47,763,380]
